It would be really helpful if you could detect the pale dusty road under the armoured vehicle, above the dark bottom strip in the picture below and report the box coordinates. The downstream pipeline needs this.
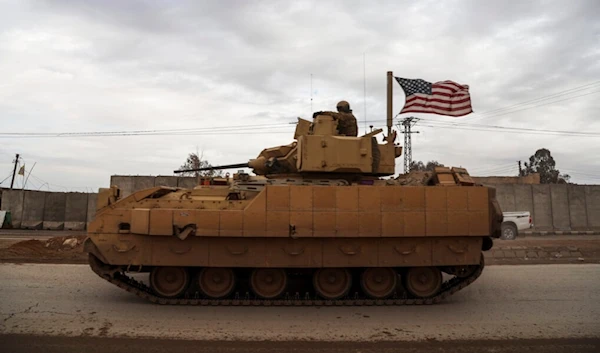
[0,264,600,342]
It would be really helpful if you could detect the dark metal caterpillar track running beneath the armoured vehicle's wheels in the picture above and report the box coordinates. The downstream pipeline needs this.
[89,254,484,306]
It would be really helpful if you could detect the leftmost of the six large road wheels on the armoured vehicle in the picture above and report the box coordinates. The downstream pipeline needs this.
[150,266,190,298]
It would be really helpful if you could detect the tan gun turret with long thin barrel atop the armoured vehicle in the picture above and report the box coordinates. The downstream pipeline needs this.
[174,114,402,178]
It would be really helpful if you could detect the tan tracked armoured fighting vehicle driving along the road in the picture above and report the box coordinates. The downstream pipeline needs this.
[85,73,502,305]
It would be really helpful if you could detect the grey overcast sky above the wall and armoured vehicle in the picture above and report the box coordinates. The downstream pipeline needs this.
[0,0,600,191]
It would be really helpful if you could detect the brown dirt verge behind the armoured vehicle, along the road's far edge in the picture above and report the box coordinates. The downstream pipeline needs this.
[0,231,600,265]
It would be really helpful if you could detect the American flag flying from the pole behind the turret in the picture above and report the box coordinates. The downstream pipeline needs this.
[396,77,473,116]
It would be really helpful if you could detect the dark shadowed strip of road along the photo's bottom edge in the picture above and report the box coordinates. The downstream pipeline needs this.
[0,335,600,353]
